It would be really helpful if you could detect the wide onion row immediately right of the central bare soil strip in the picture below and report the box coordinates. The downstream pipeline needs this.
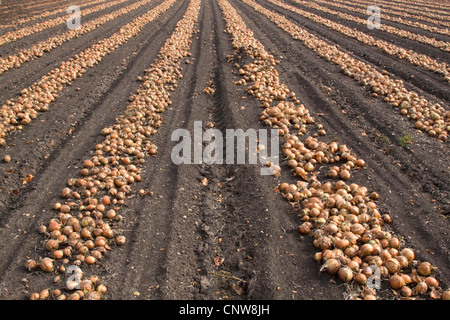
[218,0,450,300]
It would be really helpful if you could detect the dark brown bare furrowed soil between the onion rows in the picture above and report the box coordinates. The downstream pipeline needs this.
[0,0,450,300]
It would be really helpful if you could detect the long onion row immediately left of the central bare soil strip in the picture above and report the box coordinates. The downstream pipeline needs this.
[25,0,201,300]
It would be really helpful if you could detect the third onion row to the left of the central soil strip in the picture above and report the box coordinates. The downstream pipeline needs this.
[0,0,153,75]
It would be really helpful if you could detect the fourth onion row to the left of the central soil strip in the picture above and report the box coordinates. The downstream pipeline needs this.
[0,0,123,46]
